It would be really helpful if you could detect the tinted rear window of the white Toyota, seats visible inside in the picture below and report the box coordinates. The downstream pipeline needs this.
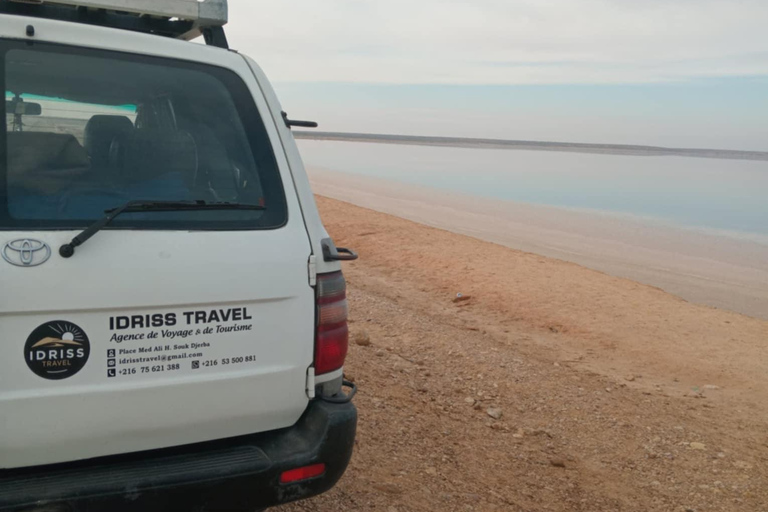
[0,42,287,230]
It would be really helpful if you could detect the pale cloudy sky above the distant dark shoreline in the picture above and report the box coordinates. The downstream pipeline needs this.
[227,0,768,149]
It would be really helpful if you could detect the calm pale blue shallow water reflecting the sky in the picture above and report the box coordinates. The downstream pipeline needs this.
[298,140,768,235]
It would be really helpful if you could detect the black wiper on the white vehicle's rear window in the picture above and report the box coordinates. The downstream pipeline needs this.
[59,200,266,258]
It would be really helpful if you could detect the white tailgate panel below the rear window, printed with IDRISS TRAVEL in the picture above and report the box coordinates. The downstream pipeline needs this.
[0,228,314,467]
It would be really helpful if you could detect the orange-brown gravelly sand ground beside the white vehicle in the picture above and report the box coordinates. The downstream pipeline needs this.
[282,198,768,512]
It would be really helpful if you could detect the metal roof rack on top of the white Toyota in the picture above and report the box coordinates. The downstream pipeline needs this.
[0,0,229,48]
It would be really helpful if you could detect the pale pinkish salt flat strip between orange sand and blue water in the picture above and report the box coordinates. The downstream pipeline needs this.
[310,168,768,319]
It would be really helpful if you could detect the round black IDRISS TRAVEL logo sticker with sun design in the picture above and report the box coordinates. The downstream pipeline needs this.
[24,320,91,380]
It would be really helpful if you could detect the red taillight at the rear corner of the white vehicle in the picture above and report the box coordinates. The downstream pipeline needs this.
[315,272,349,375]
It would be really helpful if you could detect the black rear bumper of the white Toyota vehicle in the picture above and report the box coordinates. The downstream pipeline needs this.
[0,401,357,512]
